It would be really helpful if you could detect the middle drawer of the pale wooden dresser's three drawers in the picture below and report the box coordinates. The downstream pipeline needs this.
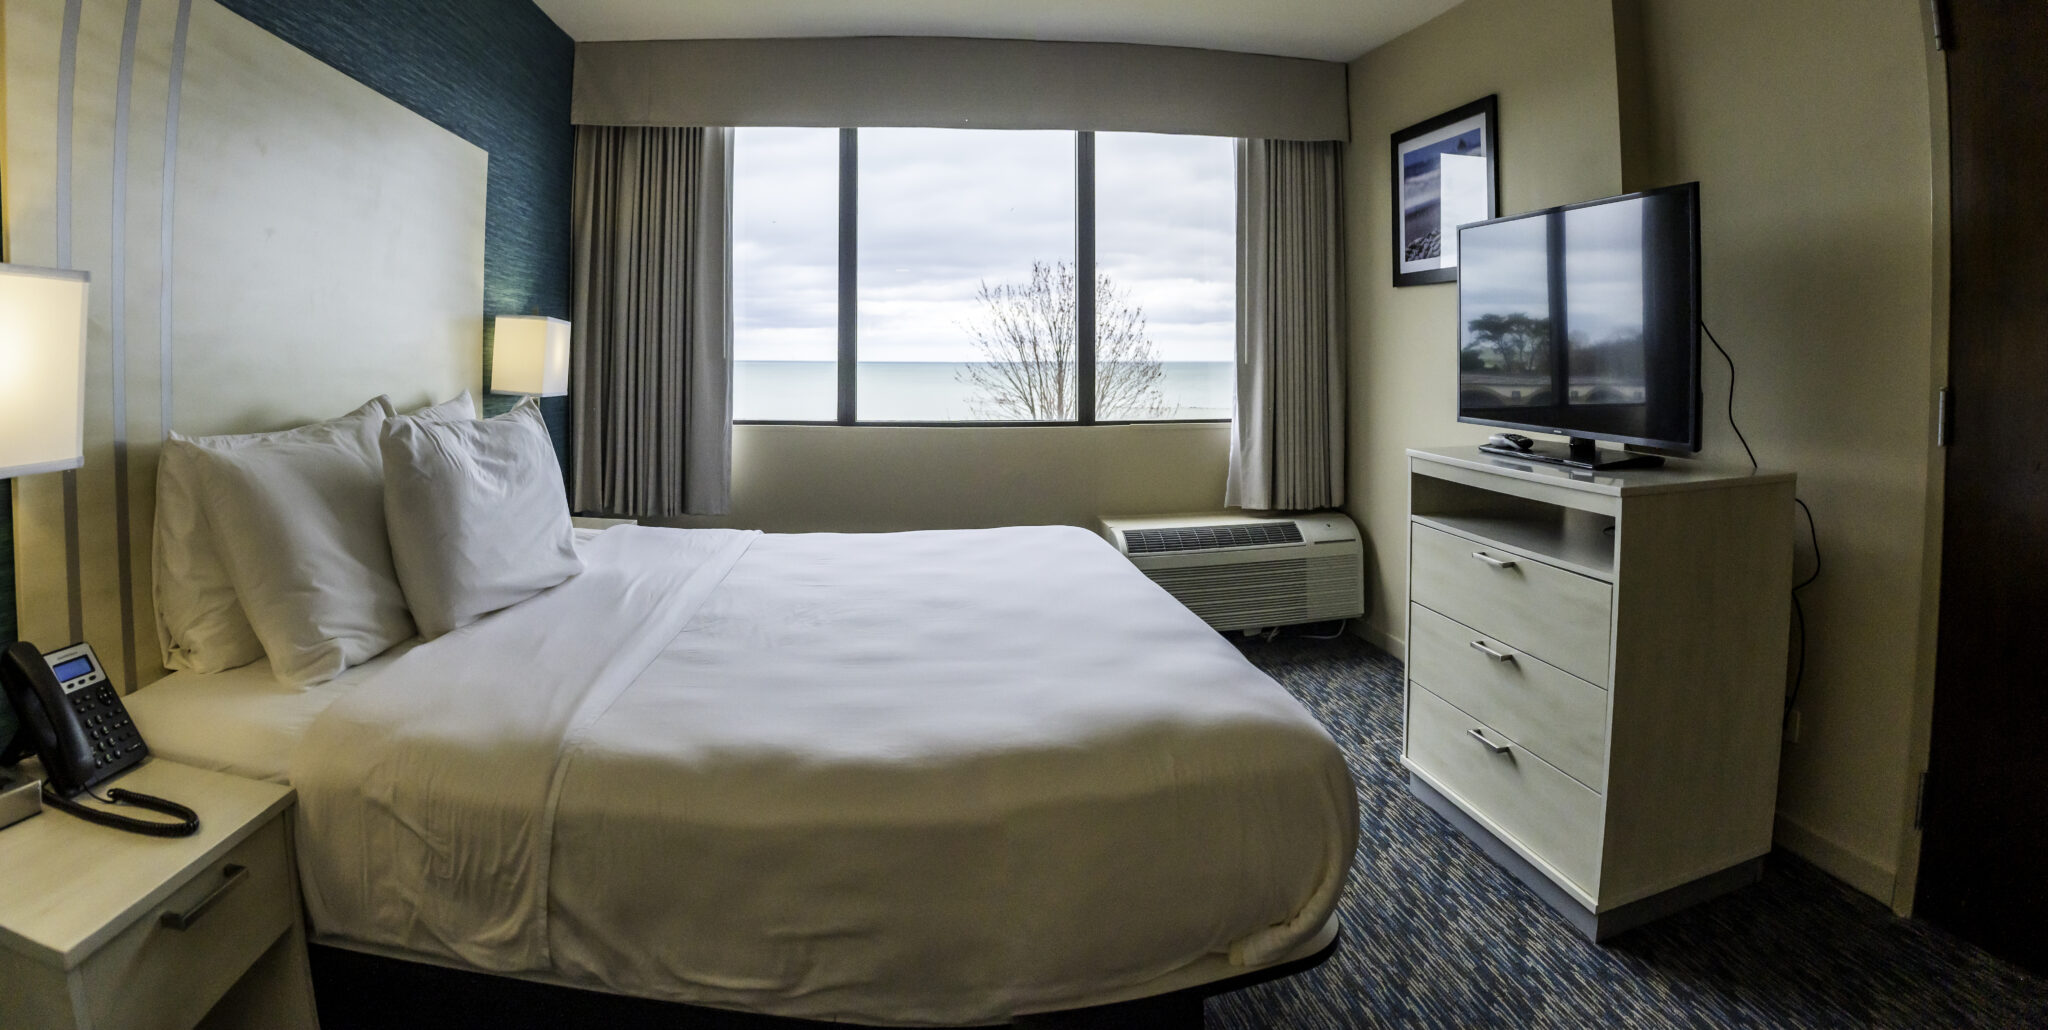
[1409,604,1608,790]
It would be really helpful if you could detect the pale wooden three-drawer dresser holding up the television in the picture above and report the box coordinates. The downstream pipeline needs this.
[1403,448,1792,940]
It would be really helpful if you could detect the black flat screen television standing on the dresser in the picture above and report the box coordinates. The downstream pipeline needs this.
[1458,182,1700,469]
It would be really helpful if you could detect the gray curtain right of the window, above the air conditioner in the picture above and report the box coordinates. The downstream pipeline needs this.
[1223,139,1346,512]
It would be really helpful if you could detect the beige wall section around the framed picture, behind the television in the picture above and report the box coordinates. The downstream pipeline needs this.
[1343,0,1622,655]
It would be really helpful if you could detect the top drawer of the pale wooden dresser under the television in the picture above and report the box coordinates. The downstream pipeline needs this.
[1409,522,1614,686]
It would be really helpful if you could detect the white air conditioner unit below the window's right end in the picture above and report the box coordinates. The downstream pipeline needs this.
[1100,512,1366,629]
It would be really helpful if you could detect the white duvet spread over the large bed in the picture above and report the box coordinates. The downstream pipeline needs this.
[291,526,1356,1024]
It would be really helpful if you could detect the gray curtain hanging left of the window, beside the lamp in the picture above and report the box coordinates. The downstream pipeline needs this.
[569,125,733,518]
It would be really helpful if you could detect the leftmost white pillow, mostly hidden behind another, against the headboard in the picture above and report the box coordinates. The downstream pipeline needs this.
[154,391,391,672]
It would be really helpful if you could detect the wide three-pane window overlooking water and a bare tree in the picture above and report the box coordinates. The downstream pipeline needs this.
[733,129,1237,424]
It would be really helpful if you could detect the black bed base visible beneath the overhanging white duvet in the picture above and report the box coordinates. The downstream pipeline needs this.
[307,924,1343,1030]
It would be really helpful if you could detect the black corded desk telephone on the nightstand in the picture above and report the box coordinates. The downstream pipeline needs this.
[0,641,199,838]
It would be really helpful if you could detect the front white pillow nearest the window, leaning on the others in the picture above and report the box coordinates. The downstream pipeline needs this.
[379,397,584,639]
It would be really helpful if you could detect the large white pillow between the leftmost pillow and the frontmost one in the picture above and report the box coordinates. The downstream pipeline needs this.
[195,405,414,684]
